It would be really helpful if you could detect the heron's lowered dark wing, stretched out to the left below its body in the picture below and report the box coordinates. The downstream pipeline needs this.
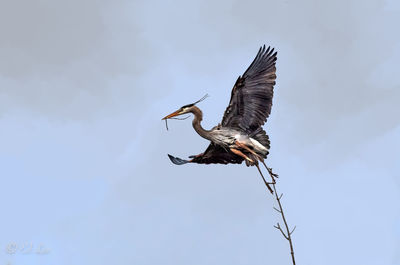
[168,143,243,165]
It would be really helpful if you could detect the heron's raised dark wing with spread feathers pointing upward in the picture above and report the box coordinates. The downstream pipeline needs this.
[221,45,277,134]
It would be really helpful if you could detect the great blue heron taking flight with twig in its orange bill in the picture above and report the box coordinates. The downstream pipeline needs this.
[163,45,277,193]
